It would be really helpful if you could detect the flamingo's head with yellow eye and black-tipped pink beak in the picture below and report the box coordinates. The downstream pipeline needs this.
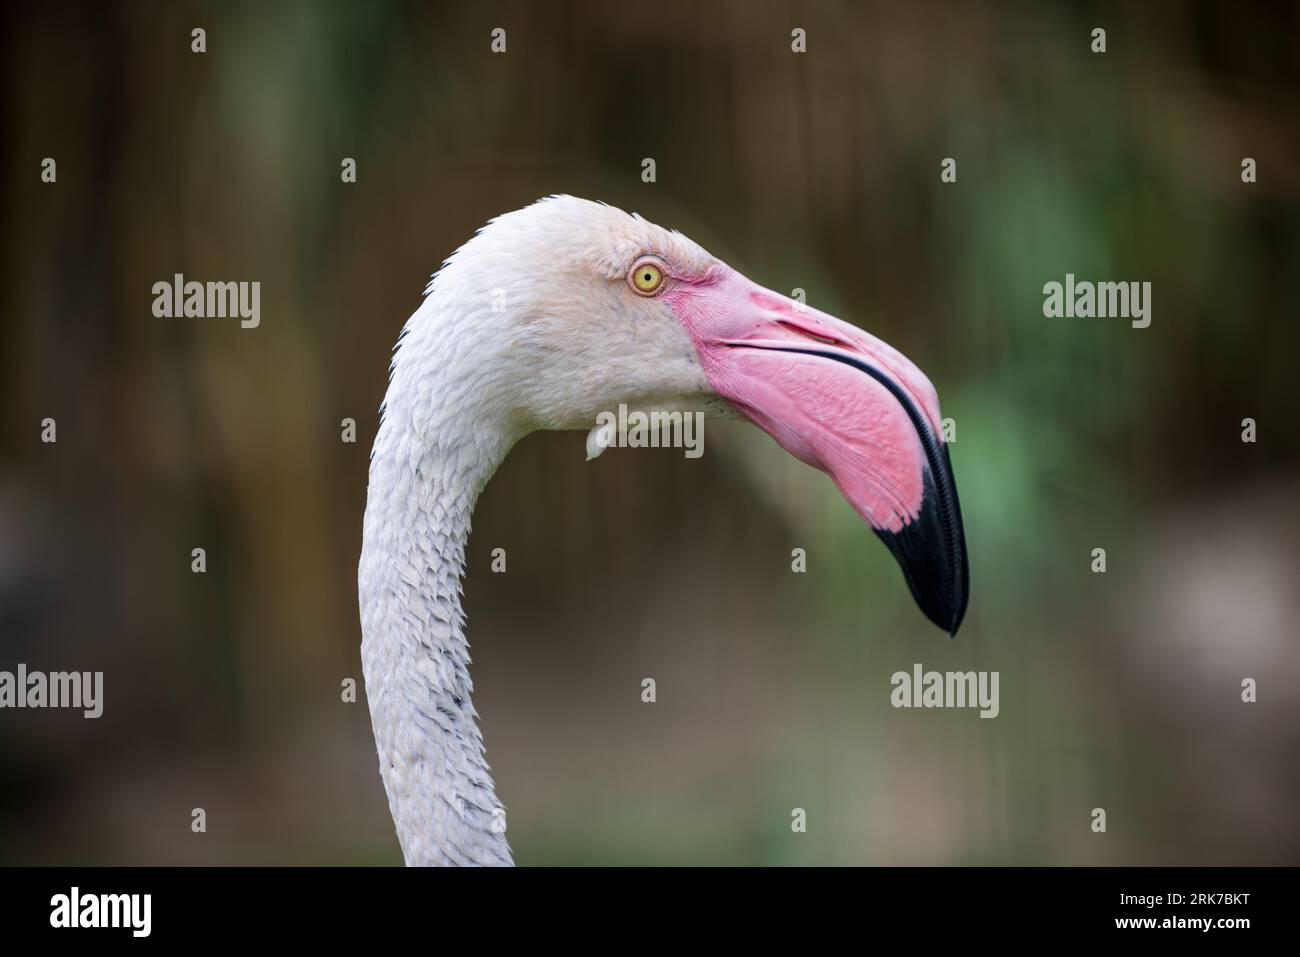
[417,196,969,635]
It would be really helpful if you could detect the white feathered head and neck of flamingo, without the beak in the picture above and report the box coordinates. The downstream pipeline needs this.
[358,196,728,865]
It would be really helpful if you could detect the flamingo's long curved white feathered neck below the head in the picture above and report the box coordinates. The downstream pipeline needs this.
[358,343,512,865]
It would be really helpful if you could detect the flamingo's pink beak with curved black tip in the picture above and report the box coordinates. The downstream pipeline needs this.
[664,267,970,635]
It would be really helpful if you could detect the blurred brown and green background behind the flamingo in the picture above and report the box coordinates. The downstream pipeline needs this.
[0,0,1300,865]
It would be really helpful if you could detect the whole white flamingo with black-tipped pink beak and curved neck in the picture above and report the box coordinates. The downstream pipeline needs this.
[358,196,969,865]
